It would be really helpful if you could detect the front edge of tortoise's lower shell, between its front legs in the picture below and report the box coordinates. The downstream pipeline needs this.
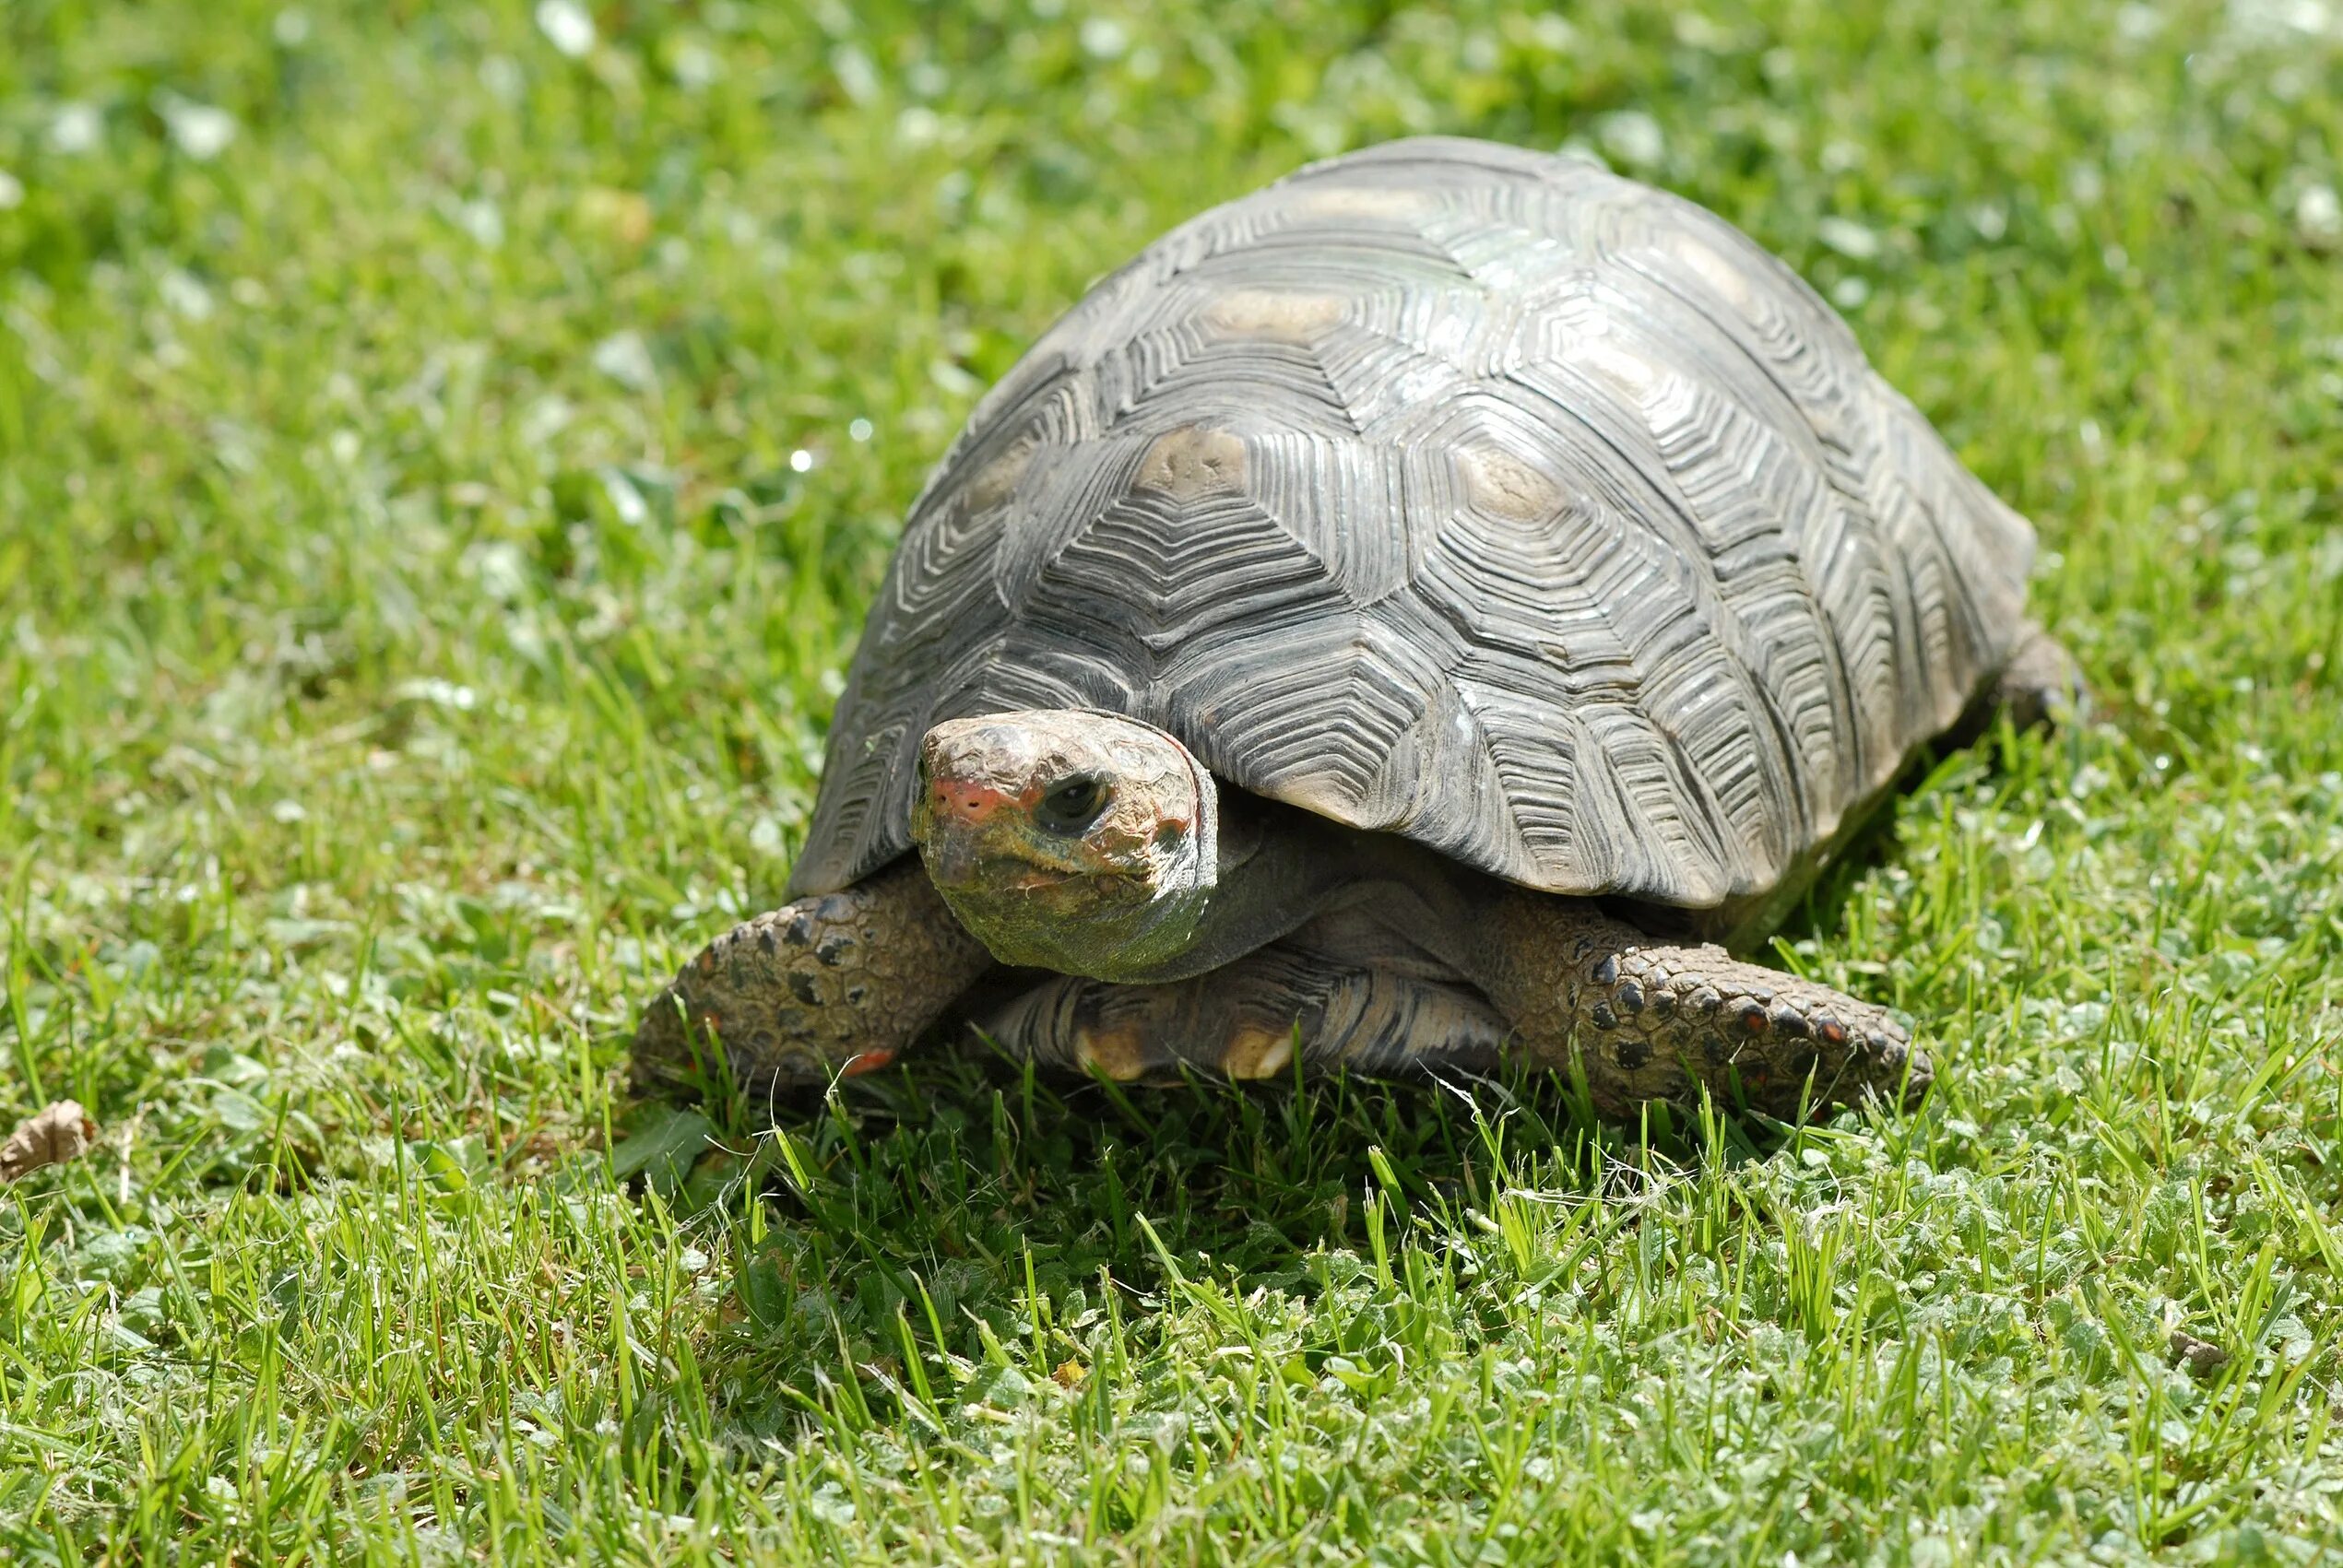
[979,942,1507,1083]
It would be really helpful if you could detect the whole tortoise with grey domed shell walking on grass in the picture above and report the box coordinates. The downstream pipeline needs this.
[635,138,2080,1115]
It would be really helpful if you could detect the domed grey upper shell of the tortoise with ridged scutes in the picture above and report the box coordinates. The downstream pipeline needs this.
[789,138,2034,910]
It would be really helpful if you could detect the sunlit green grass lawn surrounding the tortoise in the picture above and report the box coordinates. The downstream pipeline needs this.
[0,0,2343,1563]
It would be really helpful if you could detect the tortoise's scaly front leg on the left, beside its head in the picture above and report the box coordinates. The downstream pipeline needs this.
[635,855,993,1090]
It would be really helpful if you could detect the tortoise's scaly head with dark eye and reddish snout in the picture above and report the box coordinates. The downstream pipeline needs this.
[911,708,1218,980]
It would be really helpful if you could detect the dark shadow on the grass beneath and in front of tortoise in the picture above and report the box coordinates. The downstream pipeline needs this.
[633,1050,1817,1437]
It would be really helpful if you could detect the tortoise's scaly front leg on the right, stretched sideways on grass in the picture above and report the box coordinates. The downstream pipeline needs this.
[1473,890,1933,1118]
